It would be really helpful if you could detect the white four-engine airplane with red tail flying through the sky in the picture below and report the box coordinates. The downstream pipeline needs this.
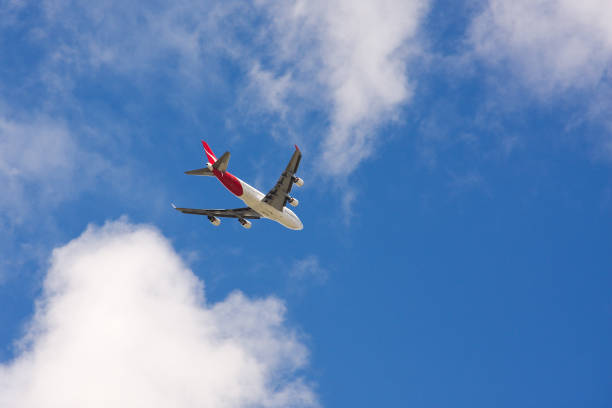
[172,140,304,230]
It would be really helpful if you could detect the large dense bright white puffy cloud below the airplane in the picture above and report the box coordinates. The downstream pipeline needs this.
[0,220,317,408]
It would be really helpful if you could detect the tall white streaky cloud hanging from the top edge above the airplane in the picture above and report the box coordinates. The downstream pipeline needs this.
[255,0,429,174]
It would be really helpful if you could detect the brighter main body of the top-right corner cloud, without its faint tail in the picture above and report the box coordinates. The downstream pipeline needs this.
[470,0,612,96]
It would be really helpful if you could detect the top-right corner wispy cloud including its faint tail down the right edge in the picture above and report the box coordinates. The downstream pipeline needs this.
[468,0,612,160]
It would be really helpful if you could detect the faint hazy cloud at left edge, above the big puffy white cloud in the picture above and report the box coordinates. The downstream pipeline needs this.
[0,114,110,224]
